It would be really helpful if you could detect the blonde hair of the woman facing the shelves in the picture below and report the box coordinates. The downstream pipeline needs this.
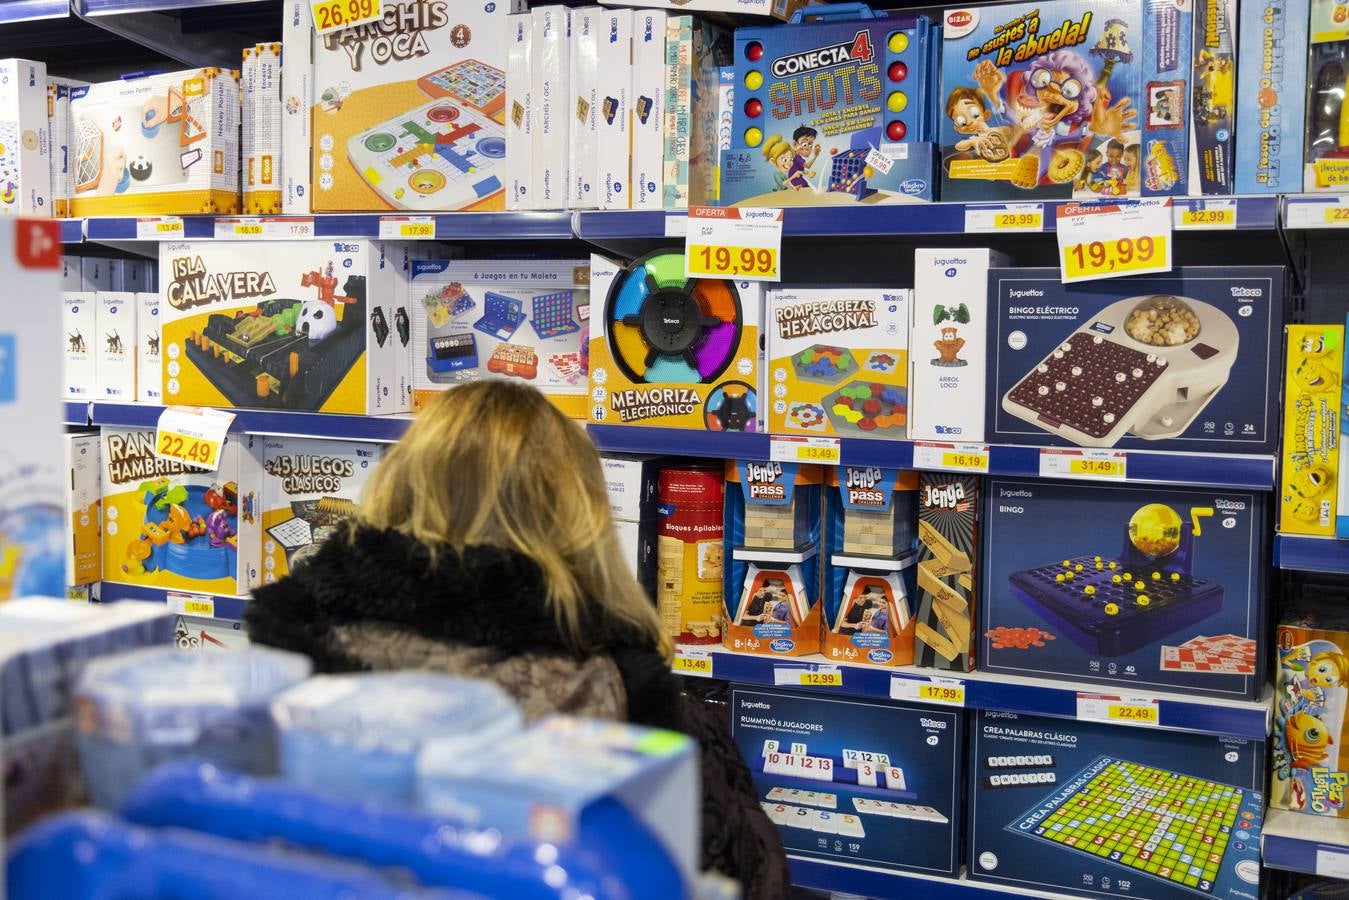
[357,379,673,657]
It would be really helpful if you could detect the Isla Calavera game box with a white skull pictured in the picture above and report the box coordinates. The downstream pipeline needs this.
[159,240,407,416]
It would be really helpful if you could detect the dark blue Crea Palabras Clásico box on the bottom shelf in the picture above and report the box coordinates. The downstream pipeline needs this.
[966,710,1265,900]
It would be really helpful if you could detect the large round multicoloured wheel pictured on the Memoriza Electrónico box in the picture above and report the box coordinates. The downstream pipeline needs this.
[604,250,742,385]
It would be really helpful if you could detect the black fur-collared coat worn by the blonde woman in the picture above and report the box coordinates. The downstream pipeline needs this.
[247,528,789,900]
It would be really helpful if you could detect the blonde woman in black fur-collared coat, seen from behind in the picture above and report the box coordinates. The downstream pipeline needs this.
[247,381,789,899]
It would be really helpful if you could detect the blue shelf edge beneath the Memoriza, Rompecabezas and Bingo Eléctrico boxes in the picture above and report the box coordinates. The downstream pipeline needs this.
[590,425,1273,491]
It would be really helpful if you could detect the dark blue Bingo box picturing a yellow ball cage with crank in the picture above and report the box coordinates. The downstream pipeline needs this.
[977,478,1268,700]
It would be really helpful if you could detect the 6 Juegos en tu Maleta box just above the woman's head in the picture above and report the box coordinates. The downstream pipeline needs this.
[407,259,591,418]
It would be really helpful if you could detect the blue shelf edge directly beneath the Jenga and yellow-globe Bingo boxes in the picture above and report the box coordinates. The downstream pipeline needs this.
[675,646,1269,741]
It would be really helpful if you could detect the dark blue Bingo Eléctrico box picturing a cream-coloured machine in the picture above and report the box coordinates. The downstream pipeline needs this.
[985,266,1284,453]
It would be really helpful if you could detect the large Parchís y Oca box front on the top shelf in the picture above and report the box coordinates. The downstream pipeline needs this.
[310,0,513,212]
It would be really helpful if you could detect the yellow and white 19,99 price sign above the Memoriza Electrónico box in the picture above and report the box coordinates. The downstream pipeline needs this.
[684,206,782,281]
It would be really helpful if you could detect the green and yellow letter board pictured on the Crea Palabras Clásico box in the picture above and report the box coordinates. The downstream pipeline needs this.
[1006,756,1261,893]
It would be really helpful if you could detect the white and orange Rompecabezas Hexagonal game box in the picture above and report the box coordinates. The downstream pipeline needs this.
[765,287,909,439]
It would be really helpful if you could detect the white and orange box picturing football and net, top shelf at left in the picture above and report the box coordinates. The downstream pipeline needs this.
[70,69,240,217]
